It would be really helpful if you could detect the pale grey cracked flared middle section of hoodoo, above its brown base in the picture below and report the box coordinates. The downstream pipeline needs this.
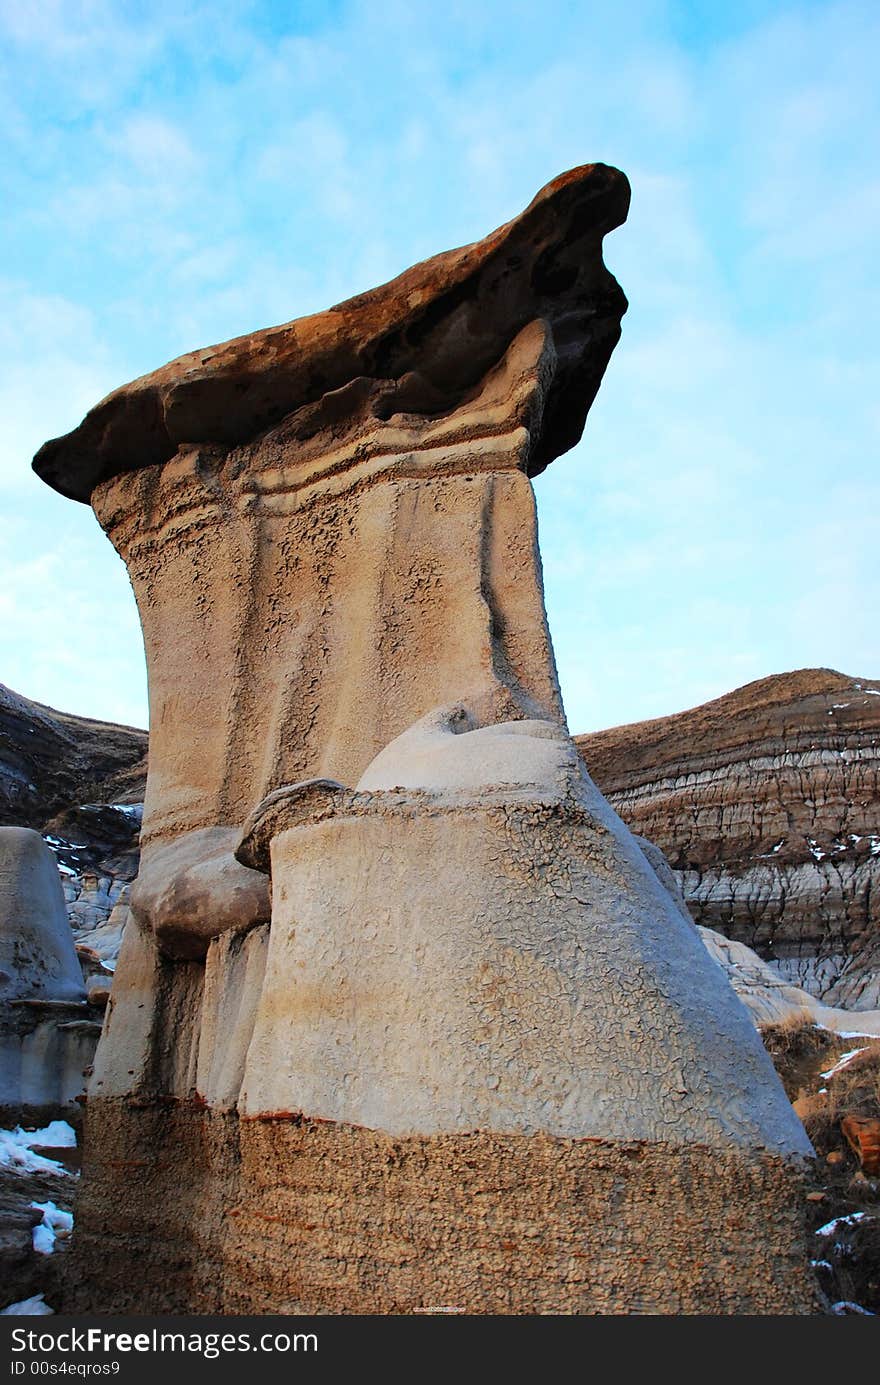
[240,723,809,1155]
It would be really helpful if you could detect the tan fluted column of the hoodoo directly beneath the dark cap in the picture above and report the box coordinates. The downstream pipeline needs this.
[94,385,563,850]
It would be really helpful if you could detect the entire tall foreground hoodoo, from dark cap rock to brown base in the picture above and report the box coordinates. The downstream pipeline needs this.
[35,165,812,1313]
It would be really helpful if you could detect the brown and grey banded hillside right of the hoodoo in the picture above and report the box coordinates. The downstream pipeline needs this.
[577,669,880,1010]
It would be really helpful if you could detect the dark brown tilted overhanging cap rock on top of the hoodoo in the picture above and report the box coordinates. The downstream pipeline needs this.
[33,163,629,501]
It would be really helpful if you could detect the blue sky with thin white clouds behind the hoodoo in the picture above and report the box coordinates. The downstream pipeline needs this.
[0,0,880,731]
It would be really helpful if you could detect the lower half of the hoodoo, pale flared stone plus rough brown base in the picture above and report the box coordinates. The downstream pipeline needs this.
[79,708,811,1313]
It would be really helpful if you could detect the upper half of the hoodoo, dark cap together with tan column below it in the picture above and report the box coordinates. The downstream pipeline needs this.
[35,166,628,848]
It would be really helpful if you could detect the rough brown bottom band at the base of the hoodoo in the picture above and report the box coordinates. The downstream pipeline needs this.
[62,1100,818,1316]
